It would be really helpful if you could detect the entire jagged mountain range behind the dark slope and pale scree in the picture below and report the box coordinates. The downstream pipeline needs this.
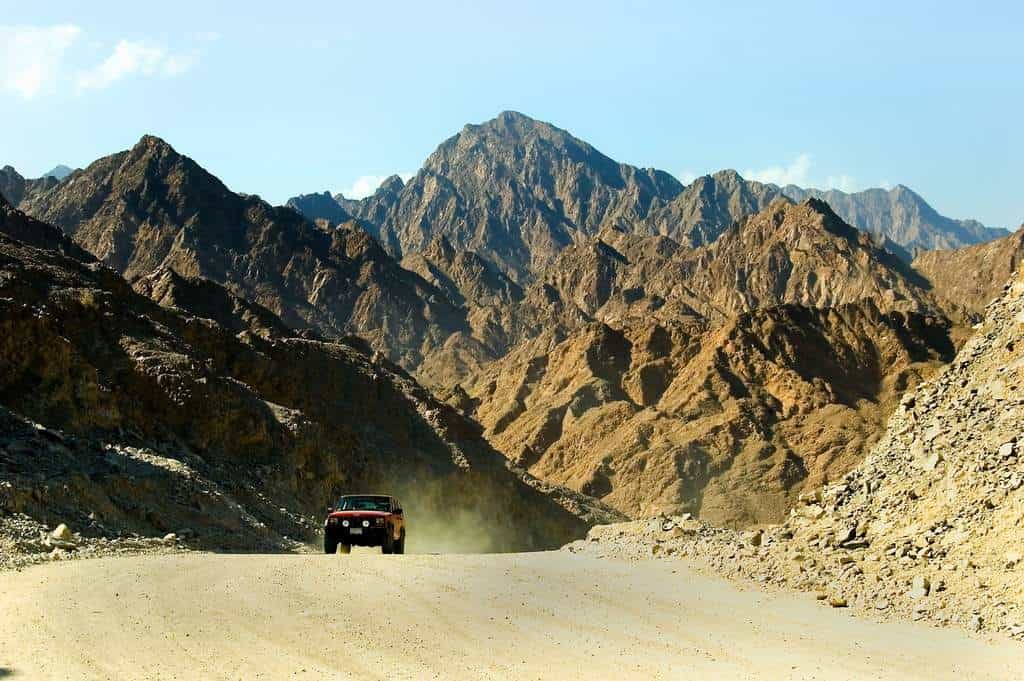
[0,112,1020,526]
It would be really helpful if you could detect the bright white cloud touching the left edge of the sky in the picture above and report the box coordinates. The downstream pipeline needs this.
[0,24,82,99]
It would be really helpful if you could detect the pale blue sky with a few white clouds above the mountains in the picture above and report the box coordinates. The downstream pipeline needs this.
[0,0,1024,227]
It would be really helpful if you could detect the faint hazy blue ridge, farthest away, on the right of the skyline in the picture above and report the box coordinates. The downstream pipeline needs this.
[782,184,1007,261]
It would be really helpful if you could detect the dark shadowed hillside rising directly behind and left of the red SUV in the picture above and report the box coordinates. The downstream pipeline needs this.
[0,204,607,565]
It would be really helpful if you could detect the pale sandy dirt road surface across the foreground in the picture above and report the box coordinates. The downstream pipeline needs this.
[0,553,1024,681]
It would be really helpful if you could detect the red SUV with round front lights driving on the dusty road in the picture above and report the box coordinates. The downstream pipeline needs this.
[324,495,406,553]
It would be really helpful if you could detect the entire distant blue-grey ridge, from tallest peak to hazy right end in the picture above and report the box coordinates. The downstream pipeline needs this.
[290,112,1006,270]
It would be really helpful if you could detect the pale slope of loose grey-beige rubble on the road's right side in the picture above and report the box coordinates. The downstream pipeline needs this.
[571,261,1024,638]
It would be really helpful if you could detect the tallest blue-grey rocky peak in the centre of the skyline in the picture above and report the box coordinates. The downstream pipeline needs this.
[329,112,682,285]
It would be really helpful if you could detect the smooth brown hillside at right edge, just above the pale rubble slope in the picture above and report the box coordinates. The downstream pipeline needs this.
[913,226,1024,323]
